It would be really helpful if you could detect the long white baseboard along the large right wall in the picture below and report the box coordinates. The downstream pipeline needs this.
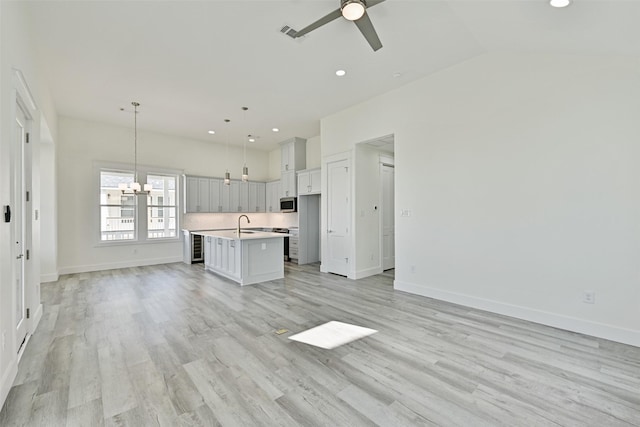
[393,280,640,347]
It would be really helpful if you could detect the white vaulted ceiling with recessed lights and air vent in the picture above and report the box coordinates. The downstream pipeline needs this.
[27,0,640,150]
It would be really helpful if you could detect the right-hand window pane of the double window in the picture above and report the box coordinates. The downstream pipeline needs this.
[147,175,177,239]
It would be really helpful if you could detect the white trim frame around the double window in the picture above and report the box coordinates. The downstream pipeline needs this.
[96,161,184,247]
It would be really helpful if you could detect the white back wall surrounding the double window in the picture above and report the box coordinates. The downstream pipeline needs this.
[57,117,268,274]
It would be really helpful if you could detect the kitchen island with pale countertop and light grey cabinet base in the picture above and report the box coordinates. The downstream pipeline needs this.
[194,230,287,286]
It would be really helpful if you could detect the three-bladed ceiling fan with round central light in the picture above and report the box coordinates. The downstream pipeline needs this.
[289,0,384,51]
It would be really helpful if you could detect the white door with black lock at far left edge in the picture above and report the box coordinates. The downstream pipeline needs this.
[11,105,27,352]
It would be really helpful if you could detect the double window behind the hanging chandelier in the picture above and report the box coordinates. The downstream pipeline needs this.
[99,168,178,243]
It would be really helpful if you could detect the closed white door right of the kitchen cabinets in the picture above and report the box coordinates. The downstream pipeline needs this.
[323,160,351,276]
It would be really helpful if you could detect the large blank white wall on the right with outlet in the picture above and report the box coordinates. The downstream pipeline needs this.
[321,55,640,346]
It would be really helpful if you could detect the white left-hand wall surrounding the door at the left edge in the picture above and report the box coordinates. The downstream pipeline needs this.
[0,1,56,412]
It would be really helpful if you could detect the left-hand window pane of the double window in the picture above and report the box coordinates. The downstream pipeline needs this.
[100,171,136,241]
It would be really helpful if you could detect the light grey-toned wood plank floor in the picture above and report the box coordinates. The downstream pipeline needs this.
[0,264,640,426]
